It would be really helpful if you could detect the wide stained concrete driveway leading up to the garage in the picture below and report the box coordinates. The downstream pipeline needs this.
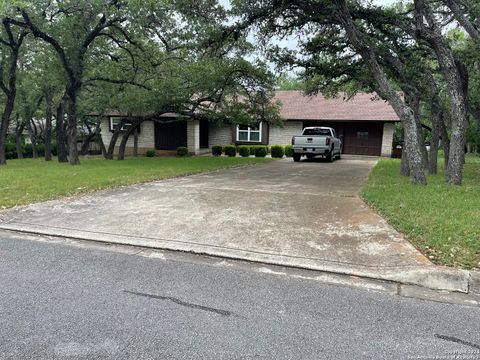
[0,157,468,288]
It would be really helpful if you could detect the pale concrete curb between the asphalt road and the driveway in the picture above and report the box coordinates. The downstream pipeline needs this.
[0,223,472,294]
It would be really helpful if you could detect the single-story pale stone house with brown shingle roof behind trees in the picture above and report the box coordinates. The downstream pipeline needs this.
[97,91,399,157]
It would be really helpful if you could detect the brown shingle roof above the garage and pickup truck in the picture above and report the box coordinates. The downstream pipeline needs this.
[275,91,399,121]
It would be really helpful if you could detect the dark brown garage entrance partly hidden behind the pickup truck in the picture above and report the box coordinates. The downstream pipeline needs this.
[303,121,383,156]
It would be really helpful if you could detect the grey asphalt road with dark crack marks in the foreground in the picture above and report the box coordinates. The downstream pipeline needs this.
[0,233,480,360]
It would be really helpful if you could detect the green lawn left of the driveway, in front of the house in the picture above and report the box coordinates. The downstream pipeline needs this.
[0,157,270,208]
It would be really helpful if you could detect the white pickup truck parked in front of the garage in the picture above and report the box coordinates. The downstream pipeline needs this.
[292,126,342,162]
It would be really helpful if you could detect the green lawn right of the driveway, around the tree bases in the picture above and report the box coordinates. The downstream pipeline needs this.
[362,156,480,269]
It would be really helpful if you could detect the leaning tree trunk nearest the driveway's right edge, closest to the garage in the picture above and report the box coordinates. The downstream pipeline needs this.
[335,0,427,185]
